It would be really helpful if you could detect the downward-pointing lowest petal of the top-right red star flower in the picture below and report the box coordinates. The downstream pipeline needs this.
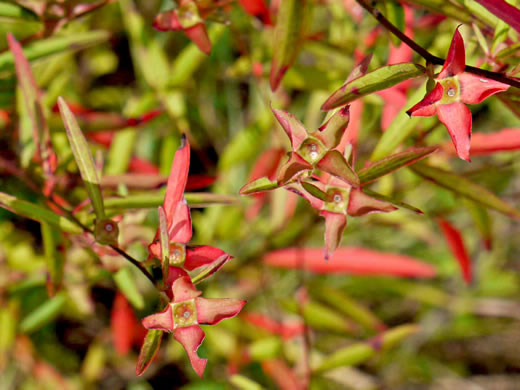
[437,102,472,161]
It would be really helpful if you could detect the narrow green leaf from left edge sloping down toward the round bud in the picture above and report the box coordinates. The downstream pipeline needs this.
[0,192,83,234]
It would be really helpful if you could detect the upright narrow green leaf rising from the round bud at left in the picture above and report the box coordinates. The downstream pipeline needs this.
[58,97,105,220]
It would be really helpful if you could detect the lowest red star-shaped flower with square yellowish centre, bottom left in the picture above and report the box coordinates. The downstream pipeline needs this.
[143,274,246,377]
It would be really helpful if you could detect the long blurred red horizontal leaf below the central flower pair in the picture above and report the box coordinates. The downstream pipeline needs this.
[263,247,435,278]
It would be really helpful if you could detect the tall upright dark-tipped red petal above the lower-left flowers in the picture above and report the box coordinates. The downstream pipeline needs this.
[163,135,190,225]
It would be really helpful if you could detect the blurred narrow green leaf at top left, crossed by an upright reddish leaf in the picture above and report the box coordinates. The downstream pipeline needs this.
[0,31,109,73]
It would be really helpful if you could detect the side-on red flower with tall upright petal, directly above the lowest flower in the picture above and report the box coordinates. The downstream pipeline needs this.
[148,136,231,286]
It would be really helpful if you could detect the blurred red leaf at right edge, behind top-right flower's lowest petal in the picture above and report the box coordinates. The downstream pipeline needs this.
[442,128,520,155]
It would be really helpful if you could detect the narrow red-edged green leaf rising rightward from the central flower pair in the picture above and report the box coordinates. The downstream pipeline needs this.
[358,146,437,185]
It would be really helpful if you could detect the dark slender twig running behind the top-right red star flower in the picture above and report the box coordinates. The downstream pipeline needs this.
[356,0,520,88]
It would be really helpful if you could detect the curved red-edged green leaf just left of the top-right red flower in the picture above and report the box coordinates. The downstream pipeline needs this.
[321,64,426,111]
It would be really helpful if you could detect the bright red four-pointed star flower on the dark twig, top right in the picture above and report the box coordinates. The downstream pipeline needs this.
[408,29,509,161]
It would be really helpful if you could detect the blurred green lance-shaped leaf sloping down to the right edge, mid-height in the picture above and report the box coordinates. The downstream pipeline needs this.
[411,163,520,219]
